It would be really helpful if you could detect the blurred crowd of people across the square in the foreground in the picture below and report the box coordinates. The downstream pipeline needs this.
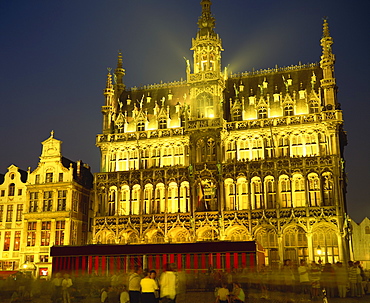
[4,259,370,303]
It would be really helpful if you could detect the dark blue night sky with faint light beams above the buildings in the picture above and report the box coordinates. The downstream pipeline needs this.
[0,0,370,222]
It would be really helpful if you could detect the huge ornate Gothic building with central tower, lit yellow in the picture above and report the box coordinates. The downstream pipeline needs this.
[93,0,348,265]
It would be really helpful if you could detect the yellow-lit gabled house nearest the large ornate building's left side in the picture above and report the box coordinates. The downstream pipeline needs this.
[20,132,93,276]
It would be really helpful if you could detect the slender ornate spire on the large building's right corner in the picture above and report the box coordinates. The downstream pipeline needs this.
[320,17,337,110]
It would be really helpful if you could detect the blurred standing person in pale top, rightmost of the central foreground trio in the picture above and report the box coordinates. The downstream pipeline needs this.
[159,263,178,303]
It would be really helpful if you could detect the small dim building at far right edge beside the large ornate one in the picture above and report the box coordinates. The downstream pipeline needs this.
[351,217,370,269]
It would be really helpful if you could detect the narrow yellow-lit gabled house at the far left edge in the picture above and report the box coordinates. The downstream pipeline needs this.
[0,165,27,271]
